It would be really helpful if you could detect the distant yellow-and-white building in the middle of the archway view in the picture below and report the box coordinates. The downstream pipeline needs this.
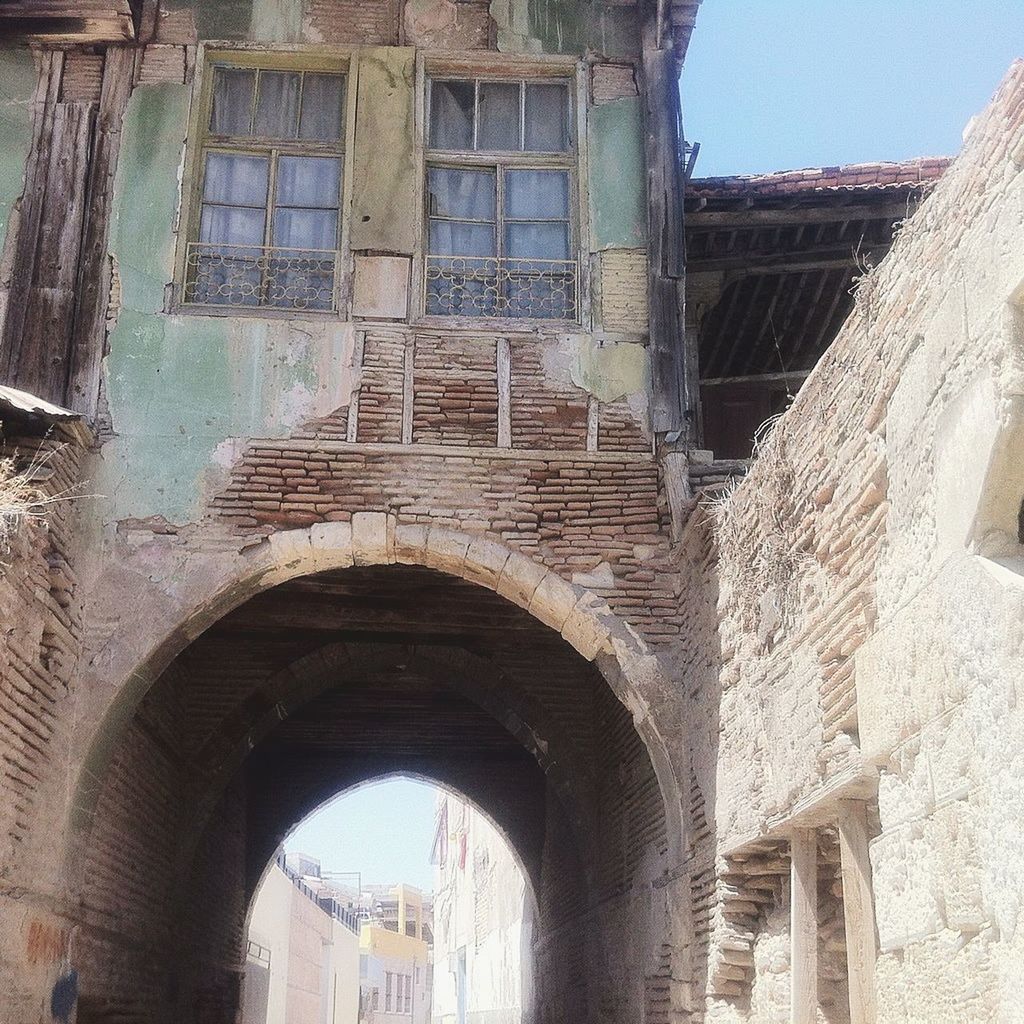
[359,885,432,1024]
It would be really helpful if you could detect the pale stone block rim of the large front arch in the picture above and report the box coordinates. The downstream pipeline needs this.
[66,512,685,889]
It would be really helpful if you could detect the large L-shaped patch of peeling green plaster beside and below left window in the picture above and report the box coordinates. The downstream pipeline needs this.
[96,85,351,522]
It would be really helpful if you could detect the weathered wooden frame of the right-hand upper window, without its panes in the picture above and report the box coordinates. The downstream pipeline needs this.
[411,50,592,335]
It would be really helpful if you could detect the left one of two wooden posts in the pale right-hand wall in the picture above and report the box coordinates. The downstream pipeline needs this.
[790,828,818,1024]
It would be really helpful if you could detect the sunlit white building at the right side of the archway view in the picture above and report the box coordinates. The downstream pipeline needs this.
[433,795,534,1024]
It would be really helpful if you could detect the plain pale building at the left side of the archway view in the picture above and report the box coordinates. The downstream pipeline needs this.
[241,855,359,1024]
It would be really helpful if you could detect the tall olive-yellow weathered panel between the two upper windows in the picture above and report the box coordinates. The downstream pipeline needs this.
[350,46,420,254]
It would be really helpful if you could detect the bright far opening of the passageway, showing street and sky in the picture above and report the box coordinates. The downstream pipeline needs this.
[242,774,538,1024]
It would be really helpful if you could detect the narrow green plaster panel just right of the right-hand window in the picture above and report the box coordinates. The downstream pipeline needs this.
[589,96,647,251]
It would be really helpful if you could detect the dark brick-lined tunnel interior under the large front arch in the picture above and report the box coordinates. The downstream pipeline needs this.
[77,565,669,1024]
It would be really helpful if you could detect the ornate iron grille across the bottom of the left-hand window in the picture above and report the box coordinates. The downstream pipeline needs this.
[184,242,338,312]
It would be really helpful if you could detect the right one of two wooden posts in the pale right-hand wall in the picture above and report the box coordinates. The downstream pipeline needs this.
[839,800,878,1024]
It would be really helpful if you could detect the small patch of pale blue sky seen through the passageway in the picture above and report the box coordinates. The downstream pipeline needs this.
[285,779,437,891]
